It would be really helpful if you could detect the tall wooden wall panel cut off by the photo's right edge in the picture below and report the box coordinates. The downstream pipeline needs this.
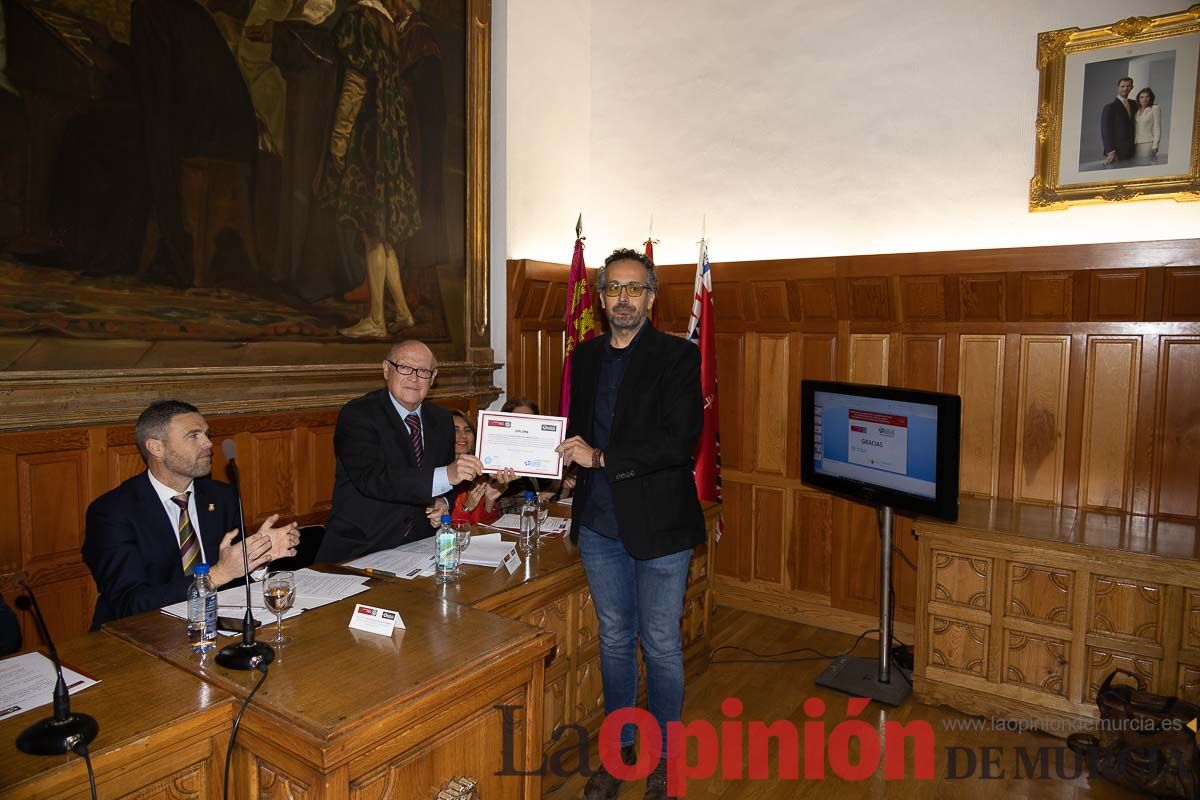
[1152,336,1200,517]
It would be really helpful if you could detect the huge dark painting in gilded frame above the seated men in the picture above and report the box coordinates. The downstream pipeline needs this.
[0,0,492,425]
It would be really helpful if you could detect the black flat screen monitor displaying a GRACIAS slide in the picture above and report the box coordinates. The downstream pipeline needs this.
[800,380,961,521]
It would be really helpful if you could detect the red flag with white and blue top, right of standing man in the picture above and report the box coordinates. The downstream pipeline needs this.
[688,239,721,506]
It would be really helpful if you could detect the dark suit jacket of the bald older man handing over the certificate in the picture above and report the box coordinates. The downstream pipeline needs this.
[317,389,454,563]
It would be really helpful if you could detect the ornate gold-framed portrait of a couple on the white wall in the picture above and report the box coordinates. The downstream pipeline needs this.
[1030,5,1200,211]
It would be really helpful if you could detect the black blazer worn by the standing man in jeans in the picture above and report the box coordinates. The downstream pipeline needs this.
[566,321,704,559]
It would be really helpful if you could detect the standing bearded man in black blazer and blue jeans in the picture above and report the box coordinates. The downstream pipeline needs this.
[559,249,704,800]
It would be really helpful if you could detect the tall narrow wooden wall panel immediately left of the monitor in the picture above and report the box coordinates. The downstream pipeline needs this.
[748,333,797,475]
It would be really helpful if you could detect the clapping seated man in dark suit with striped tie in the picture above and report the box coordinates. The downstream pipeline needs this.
[83,401,300,630]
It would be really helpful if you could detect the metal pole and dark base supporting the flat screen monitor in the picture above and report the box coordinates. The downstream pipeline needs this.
[817,506,912,706]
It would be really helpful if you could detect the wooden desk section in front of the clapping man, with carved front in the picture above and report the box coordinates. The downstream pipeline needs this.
[106,582,553,800]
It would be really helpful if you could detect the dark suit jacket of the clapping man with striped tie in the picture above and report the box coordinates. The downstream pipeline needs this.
[83,473,238,630]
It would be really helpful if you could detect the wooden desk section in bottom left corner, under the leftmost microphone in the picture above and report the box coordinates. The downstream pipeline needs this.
[0,633,233,800]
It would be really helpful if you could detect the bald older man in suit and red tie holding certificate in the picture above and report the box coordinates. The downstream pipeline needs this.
[317,339,484,561]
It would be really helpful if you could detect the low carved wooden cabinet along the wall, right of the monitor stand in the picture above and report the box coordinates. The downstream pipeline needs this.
[913,499,1200,735]
